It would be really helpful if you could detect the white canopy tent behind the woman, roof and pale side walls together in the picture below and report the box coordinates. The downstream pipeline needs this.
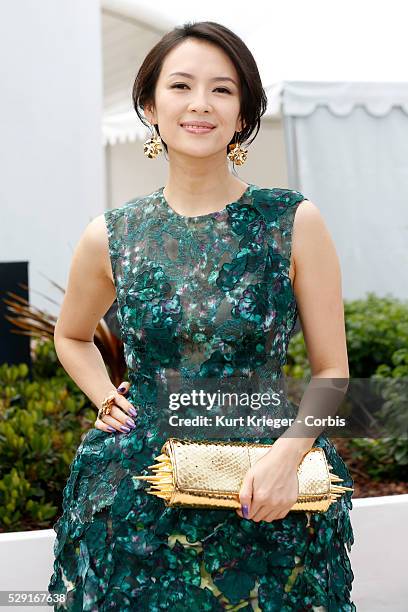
[102,0,408,299]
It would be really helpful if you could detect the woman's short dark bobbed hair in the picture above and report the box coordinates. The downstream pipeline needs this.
[132,21,268,159]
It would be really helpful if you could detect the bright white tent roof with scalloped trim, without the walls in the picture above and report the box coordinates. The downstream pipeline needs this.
[102,0,408,144]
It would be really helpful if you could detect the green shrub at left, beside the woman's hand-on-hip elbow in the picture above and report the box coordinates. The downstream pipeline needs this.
[0,341,96,531]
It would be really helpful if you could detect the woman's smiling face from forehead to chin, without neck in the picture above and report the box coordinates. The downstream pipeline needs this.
[144,38,242,158]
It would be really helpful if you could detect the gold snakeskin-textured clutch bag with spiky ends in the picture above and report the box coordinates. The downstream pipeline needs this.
[133,438,354,512]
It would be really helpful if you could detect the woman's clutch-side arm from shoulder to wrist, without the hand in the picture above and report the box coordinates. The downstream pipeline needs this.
[280,200,349,458]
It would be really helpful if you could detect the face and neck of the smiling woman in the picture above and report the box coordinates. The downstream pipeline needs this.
[143,38,249,175]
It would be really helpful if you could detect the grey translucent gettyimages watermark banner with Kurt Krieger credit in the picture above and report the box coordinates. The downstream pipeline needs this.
[156,377,408,441]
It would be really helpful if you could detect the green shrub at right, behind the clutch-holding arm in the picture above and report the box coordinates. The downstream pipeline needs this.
[285,292,408,480]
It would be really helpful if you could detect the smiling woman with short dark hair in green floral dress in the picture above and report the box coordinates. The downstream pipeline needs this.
[49,22,355,612]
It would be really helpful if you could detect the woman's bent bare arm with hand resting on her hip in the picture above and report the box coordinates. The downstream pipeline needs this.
[54,214,137,431]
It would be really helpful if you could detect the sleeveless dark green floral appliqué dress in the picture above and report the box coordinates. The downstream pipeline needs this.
[48,183,356,612]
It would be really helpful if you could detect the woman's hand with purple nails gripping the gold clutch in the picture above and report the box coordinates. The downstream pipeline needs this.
[236,438,305,522]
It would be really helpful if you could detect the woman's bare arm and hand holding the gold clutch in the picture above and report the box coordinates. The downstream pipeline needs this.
[236,200,349,522]
